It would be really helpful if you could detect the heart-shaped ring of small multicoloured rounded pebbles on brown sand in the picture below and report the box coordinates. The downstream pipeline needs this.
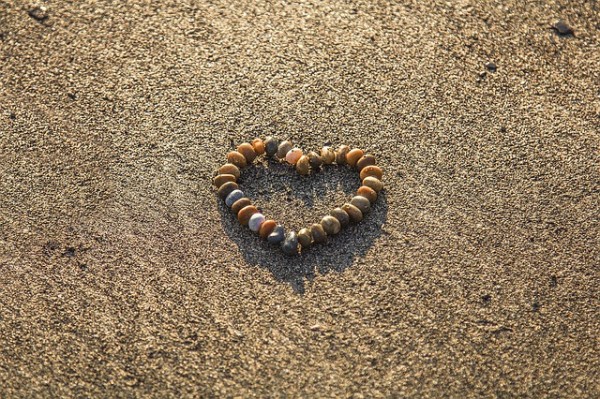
[213,137,383,255]
